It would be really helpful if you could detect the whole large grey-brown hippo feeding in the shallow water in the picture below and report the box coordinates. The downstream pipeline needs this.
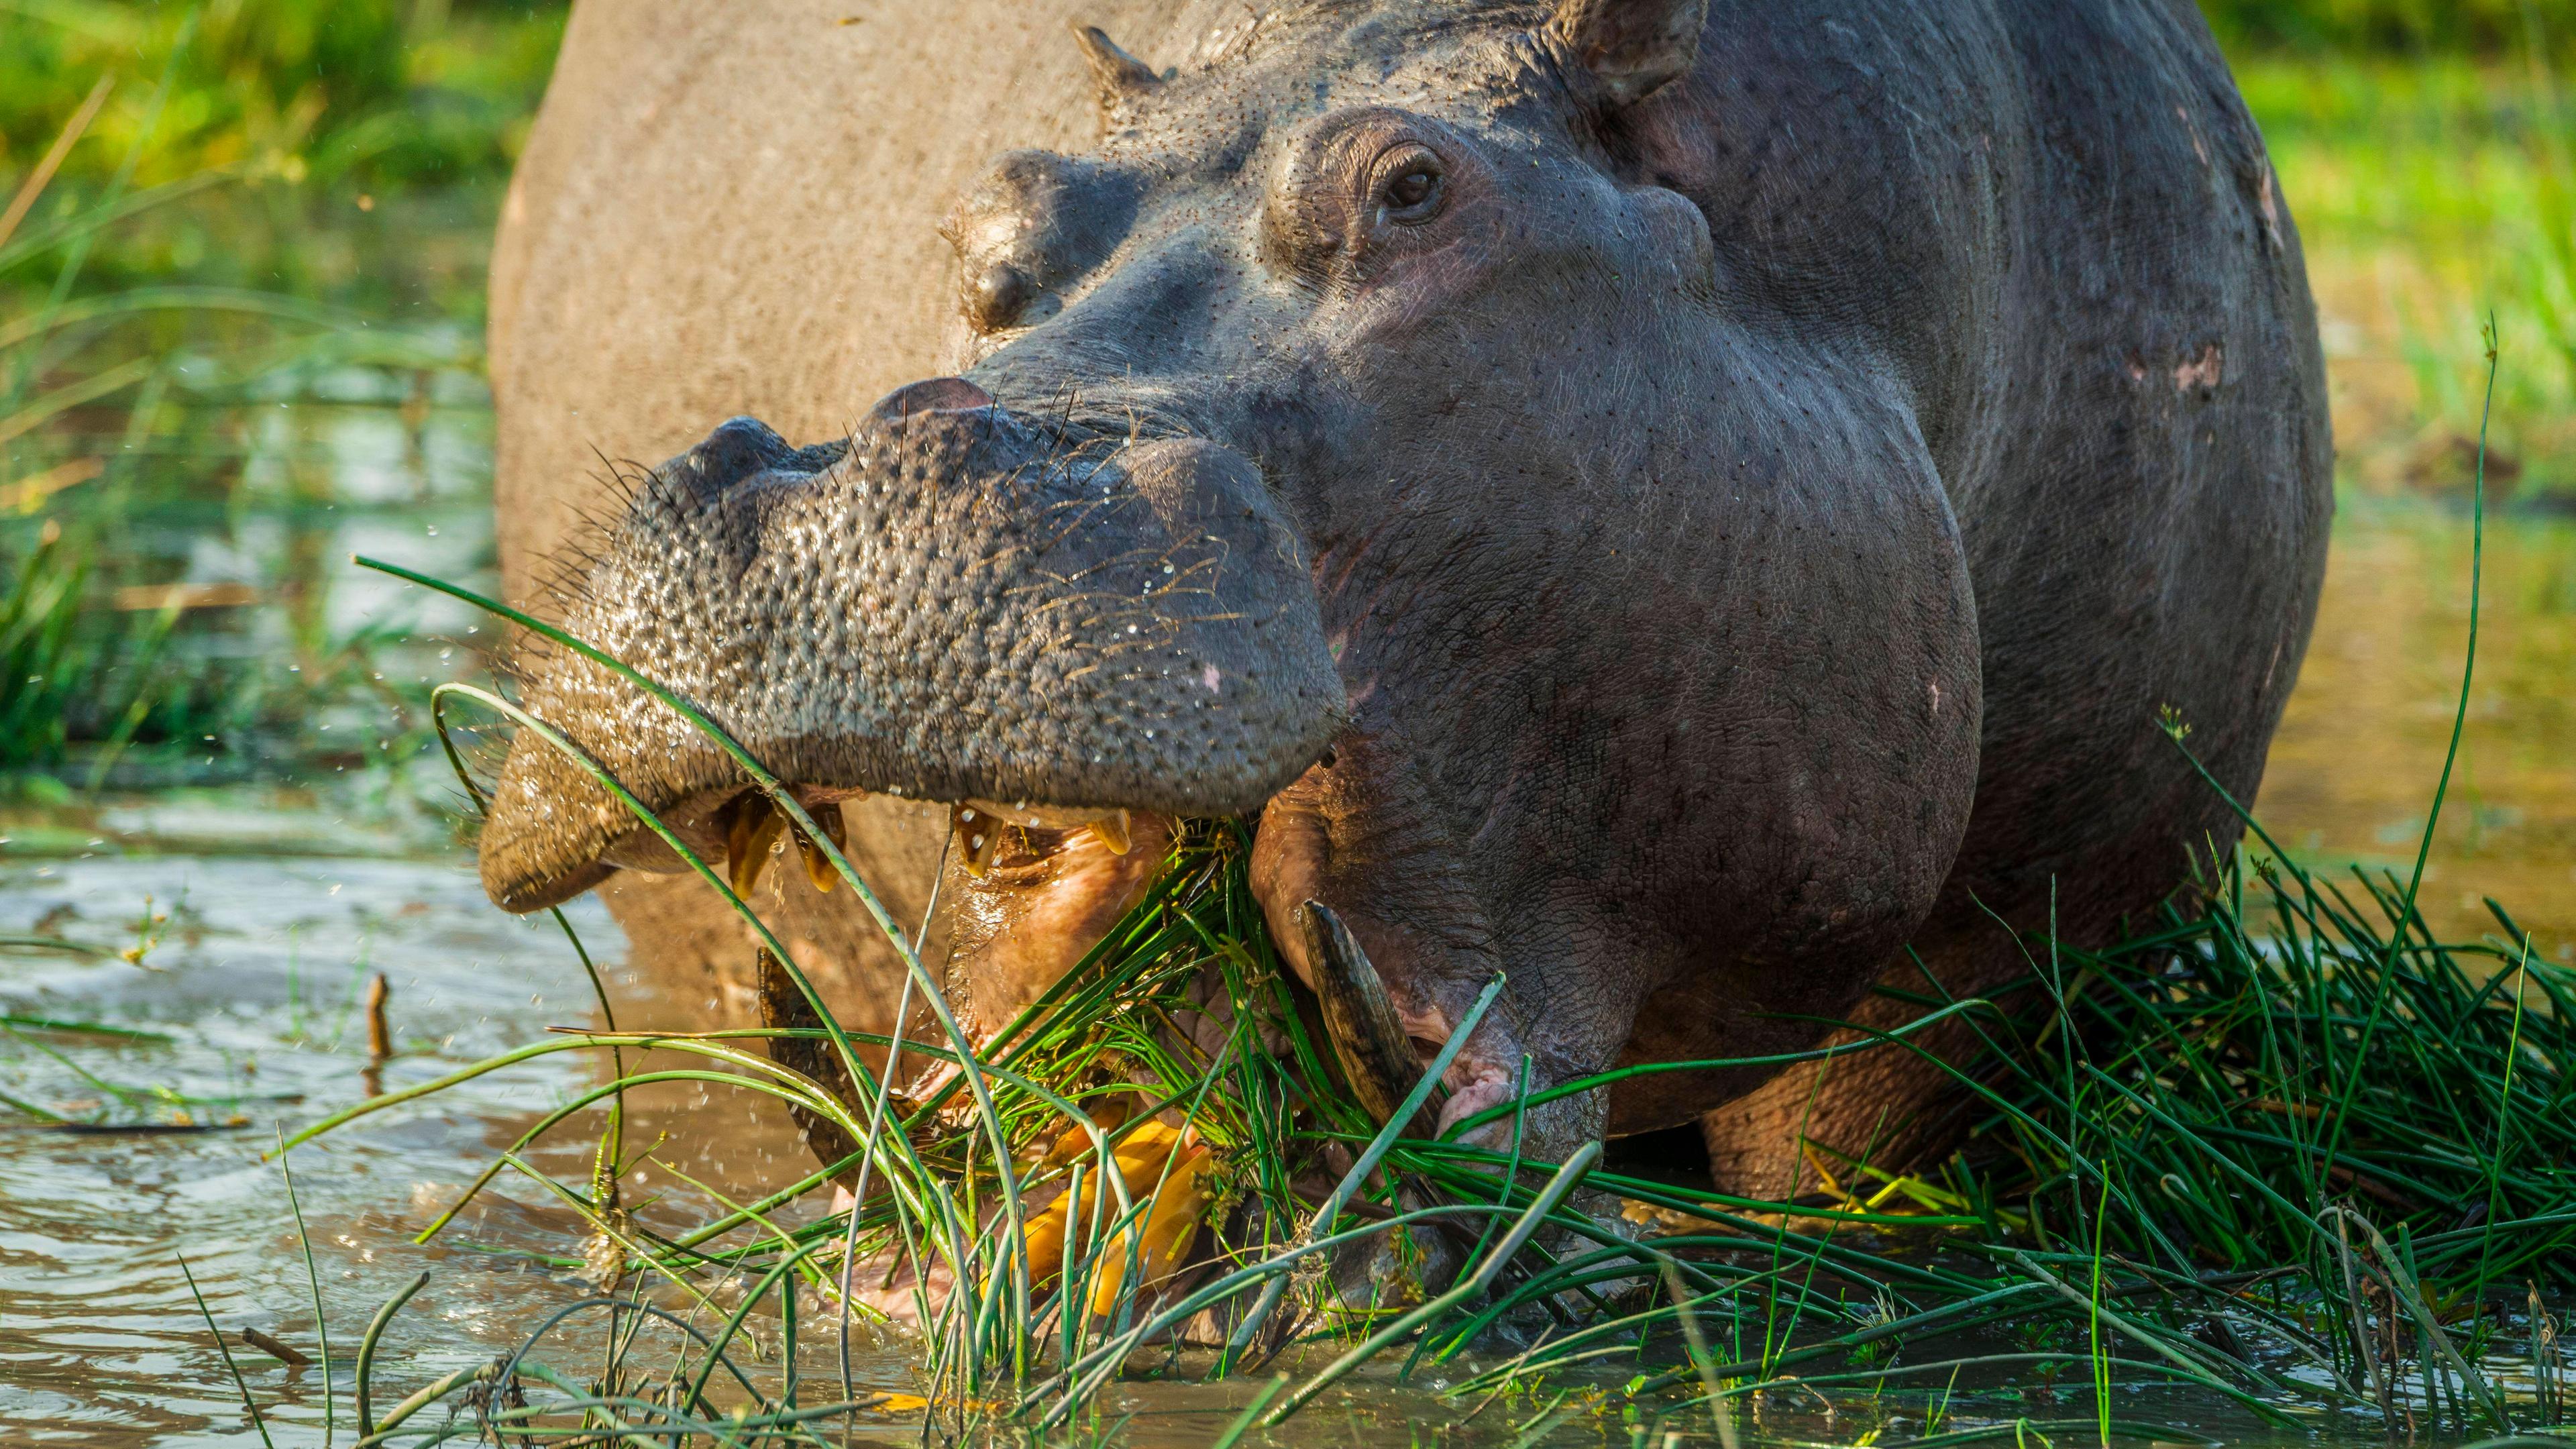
[479,0,2331,1196]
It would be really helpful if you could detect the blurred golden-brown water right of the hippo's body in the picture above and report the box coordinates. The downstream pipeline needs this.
[2254,498,2576,962]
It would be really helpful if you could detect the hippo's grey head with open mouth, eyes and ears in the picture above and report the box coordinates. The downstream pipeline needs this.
[482,0,1976,1155]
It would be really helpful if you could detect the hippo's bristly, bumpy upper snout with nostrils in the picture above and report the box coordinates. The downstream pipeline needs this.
[482,392,1342,910]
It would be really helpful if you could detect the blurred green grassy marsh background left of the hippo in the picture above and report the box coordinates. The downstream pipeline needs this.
[0,0,564,804]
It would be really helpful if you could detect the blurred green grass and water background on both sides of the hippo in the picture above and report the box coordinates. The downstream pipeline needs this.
[0,0,2576,949]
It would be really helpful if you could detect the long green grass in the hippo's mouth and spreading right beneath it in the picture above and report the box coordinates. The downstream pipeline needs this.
[245,356,2576,1446]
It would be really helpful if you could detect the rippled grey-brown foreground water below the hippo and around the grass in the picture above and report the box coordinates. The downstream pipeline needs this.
[0,853,2390,1449]
